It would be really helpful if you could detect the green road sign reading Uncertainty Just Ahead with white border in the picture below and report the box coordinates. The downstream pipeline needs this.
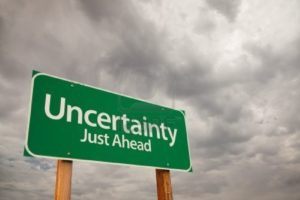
[25,73,191,171]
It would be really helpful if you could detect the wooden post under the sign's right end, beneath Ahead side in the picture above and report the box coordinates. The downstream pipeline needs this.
[156,169,173,200]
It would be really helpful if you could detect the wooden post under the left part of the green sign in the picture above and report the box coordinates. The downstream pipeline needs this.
[54,160,73,200]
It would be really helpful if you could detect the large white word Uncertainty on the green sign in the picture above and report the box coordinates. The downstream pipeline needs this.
[45,94,177,147]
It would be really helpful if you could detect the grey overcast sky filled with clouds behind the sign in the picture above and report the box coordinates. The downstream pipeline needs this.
[0,0,300,200]
